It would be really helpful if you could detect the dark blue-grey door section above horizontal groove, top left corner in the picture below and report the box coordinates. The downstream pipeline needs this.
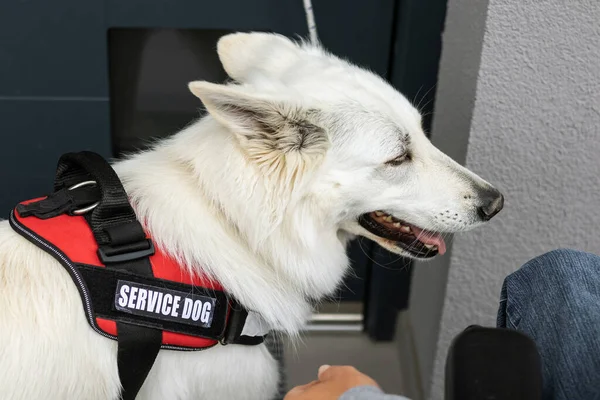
[0,0,108,97]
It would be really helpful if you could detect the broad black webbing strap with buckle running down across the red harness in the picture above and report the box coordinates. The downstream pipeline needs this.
[54,151,162,400]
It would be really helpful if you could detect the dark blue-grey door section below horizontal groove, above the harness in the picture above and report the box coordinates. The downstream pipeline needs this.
[0,100,110,212]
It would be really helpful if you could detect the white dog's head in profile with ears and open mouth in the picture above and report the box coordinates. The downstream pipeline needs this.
[190,33,503,258]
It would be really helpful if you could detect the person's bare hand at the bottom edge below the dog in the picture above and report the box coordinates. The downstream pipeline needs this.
[284,365,379,400]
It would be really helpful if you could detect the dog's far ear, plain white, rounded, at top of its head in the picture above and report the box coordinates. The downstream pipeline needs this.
[217,32,302,82]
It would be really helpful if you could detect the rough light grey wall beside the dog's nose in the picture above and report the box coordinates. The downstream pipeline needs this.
[411,0,600,400]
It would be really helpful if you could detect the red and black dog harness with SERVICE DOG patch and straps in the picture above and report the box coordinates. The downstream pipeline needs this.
[10,151,264,400]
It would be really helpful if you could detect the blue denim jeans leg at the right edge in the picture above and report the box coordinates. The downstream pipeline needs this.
[498,250,600,400]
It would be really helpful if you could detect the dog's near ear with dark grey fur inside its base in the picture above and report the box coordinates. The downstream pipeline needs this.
[189,81,329,168]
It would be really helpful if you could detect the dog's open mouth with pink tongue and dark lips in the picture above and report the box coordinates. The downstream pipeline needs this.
[358,211,446,258]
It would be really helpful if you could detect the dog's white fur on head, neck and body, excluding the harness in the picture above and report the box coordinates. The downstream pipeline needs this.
[0,33,502,400]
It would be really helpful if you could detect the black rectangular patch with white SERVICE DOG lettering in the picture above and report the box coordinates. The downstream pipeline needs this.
[114,280,216,328]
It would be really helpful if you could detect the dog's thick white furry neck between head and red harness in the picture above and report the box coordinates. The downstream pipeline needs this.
[115,117,348,334]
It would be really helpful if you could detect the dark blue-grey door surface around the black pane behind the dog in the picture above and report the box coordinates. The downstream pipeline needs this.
[0,0,394,212]
